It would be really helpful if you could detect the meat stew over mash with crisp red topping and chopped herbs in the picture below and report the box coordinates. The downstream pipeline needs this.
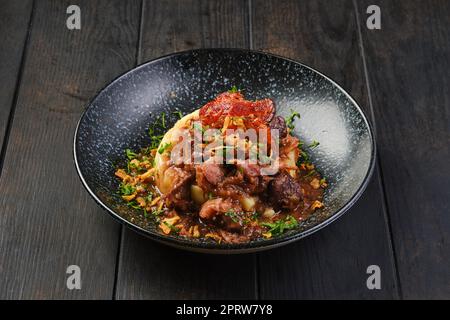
[115,87,327,243]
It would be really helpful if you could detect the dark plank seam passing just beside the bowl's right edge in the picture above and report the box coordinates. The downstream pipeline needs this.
[353,0,403,299]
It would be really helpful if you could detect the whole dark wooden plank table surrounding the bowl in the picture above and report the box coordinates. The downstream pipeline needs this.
[0,0,450,299]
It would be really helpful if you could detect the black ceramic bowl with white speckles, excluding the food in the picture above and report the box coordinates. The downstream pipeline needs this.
[74,49,375,253]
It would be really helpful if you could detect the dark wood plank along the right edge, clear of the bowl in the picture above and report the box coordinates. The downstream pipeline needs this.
[358,0,450,299]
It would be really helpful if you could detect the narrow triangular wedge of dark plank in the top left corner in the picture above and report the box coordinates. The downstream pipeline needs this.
[0,0,33,154]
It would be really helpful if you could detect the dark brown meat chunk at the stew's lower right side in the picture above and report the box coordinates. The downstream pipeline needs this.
[269,172,302,209]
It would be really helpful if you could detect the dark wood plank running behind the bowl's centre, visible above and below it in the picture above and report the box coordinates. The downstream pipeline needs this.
[116,0,256,299]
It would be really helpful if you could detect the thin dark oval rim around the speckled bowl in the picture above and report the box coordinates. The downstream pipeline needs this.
[72,48,377,254]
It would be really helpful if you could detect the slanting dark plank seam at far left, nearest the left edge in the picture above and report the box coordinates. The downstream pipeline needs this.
[0,0,35,178]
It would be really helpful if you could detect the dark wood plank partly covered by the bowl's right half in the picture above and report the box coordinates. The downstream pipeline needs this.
[251,0,397,299]
